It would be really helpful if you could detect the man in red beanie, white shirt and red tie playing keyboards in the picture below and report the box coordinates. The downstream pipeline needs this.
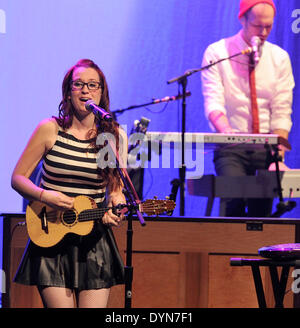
[202,0,294,217]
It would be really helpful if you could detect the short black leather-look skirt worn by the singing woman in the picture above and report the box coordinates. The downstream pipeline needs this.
[14,222,124,291]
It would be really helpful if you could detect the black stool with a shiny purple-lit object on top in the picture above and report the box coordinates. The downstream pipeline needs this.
[230,244,300,308]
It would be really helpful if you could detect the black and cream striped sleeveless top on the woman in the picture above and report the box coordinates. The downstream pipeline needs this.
[41,129,105,203]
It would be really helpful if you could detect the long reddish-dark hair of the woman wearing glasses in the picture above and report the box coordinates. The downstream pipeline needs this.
[54,59,121,190]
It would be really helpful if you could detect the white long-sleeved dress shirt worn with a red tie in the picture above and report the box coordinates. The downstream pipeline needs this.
[202,31,295,133]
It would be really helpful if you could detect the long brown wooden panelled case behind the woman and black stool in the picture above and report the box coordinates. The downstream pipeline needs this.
[1,213,300,308]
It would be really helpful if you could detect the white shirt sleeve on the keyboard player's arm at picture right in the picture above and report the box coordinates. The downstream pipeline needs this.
[270,52,295,132]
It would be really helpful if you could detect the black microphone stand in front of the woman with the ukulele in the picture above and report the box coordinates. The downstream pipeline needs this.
[107,134,146,308]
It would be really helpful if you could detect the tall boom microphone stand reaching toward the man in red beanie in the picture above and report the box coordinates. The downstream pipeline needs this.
[167,47,253,216]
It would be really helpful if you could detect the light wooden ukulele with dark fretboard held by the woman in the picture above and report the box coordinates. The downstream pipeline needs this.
[26,196,175,247]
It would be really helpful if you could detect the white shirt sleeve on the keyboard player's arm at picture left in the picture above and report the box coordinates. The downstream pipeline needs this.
[201,44,226,119]
